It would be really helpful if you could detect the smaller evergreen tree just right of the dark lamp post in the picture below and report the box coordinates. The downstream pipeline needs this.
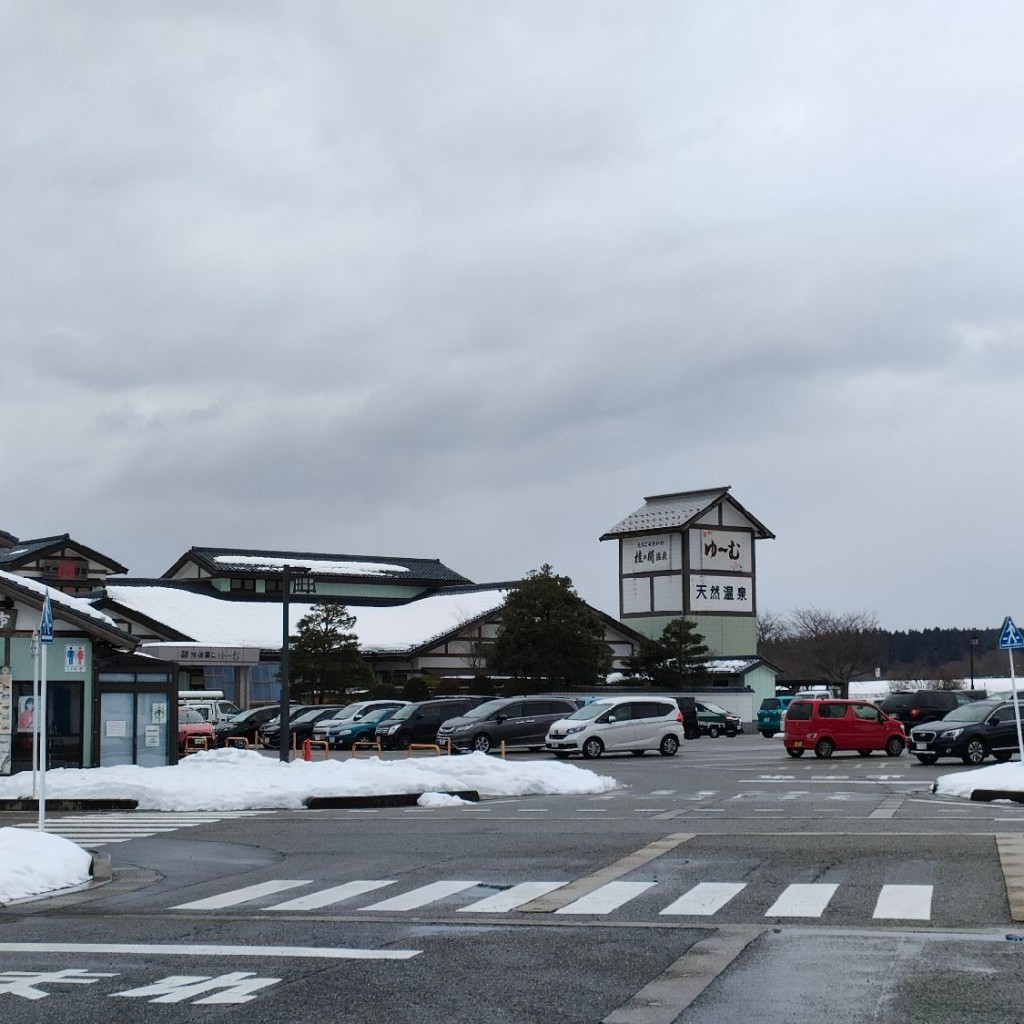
[289,604,374,702]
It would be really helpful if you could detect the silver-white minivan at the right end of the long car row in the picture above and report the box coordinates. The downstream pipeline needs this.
[544,696,684,758]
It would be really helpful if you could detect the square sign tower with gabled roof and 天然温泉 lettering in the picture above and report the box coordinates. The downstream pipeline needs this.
[601,487,775,657]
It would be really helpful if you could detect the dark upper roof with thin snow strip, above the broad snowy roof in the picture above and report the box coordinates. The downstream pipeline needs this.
[162,547,472,586]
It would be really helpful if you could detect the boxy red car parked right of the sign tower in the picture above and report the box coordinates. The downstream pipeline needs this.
[783,698,906,758]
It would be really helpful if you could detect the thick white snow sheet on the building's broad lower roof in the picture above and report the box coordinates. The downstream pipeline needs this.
[104,584,507,653]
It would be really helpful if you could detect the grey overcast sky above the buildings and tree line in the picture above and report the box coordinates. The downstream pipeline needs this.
[0,0,1024,629]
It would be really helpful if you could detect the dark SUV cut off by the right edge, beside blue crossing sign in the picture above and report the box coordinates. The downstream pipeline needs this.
[908,698,1018,765]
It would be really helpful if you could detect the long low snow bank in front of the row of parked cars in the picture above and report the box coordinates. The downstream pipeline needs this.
[0,748,618,811]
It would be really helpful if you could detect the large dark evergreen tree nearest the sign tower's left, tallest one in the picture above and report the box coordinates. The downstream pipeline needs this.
[489,564,611,686]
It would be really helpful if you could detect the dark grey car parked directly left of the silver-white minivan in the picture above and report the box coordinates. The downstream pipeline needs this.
[437,693,580,754]
